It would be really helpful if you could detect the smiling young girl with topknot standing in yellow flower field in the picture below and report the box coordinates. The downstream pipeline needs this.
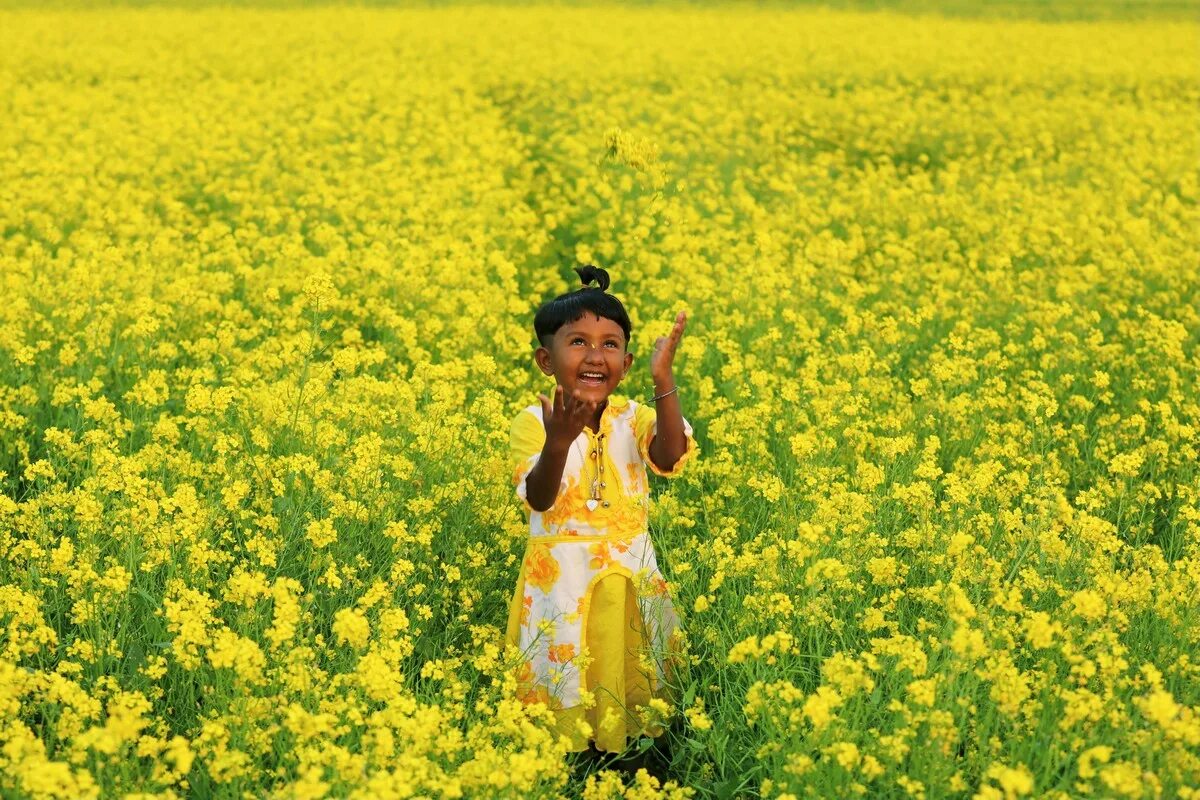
[508,265,697,752]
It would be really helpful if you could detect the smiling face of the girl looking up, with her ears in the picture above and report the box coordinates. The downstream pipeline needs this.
[534,312,634,401]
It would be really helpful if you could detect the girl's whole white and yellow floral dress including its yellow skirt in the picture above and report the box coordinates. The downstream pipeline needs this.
[508,395,697,751]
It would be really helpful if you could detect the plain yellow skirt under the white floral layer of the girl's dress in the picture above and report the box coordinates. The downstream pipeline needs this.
[506,565,673,752]
